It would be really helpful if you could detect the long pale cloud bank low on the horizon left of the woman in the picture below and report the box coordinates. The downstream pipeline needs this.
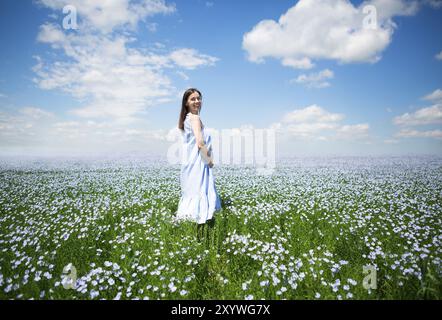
[0,107,170,156]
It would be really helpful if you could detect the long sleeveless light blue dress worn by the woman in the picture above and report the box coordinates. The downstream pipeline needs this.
[175,113,221,224]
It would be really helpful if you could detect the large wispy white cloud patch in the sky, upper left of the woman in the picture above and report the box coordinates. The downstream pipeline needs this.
[34,25,173,117]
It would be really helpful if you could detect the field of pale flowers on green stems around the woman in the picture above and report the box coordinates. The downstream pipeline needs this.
[0,156,442,299]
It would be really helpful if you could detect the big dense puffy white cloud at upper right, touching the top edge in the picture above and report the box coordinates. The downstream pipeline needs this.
[242,0,418,69]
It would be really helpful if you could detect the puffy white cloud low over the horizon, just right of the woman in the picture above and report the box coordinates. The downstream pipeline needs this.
[269,105,370,141]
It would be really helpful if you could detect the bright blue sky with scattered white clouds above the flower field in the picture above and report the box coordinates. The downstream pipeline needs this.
[0,0,442,155]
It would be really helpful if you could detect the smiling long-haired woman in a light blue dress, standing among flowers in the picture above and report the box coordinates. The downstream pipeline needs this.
[176,88,221,225]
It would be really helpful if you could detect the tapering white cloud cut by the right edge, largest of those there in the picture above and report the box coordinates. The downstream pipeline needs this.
[393,104,442,126]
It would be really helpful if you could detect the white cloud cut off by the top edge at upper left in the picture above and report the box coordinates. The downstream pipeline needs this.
[39,0,176,33]
